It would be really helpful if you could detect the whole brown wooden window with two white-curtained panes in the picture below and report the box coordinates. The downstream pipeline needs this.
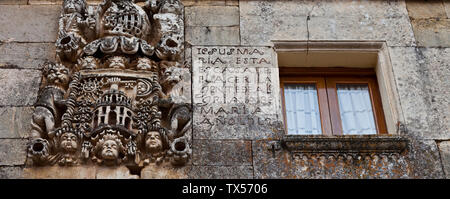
[280,68,387,135]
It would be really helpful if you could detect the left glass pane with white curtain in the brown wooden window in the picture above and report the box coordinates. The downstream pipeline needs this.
[284,84,322,135]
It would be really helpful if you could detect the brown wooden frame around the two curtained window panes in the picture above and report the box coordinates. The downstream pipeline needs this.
[280,67,387,136]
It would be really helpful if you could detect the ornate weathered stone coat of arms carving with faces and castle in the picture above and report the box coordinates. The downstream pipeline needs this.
[28,0,192,169]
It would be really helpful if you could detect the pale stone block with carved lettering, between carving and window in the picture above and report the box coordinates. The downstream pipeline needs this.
[192,46,280,139]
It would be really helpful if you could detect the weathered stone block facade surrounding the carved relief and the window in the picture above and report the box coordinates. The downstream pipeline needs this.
[0,0,450,179]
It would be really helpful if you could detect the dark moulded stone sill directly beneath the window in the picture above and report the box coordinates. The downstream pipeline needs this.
[281,135,408,153]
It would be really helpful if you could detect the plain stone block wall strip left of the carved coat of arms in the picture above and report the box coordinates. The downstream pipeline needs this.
[0,1,60,178]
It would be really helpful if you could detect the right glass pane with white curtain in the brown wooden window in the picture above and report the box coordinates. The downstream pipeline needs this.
[336,84,377,135]
